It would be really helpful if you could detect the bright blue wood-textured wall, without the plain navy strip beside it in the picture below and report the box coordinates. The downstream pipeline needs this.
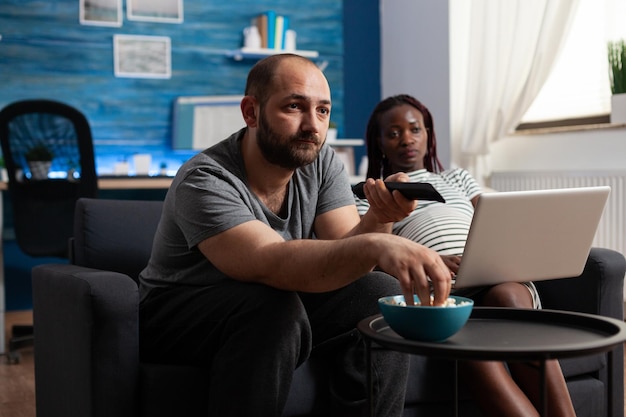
[0,0,344,172]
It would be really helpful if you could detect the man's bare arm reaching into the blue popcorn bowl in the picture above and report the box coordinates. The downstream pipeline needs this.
[198,216,451,304]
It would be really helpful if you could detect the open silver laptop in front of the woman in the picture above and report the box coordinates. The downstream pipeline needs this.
[454,186,611,288]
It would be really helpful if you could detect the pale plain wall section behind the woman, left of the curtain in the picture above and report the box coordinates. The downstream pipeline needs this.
[380,0,450,167]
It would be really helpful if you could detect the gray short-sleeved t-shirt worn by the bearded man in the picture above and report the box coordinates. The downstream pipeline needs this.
[139,129,354,299]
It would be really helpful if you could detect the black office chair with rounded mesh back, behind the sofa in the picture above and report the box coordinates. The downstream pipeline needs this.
[0,100,98,363]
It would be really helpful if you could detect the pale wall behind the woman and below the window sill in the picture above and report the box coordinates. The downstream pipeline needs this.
[380,0,626,179]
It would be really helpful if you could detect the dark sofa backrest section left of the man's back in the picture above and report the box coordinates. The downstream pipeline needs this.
[70,198,163,281]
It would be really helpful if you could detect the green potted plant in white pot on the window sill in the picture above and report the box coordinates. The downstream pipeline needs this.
[608,39,626,124]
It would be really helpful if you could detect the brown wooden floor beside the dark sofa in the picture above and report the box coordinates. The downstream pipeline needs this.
[0,311,626,417]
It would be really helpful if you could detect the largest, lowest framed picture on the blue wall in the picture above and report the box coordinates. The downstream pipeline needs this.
[113,35,172,78]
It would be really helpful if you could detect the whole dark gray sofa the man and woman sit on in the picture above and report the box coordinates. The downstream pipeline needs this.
[33,199,626,417]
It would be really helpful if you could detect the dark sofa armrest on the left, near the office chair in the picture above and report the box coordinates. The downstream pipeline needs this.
[32,264,139,417]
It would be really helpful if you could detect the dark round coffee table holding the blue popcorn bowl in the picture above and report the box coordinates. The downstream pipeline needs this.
[357,307,626,416]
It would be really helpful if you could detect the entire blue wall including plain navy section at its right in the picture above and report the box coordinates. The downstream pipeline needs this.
[0,0,380,310]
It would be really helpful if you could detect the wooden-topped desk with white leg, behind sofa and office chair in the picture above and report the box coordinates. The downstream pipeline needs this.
[0,176,173,355]
